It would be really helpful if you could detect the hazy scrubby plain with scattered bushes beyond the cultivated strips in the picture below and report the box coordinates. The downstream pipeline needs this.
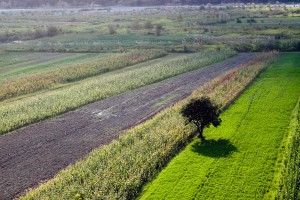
[0,5,300,53]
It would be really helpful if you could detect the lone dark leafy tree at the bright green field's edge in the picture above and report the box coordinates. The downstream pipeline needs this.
[181,97,222,139]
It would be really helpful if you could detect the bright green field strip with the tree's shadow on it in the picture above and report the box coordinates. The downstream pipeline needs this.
[139,54,300,199]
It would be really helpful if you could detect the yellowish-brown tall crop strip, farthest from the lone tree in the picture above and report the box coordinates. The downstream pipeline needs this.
[0,50,166,100]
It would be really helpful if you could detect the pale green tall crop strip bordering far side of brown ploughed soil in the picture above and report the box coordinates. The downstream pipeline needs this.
[0,51,234,134]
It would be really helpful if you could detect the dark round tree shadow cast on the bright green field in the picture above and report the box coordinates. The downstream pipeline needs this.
[192,139,237,158]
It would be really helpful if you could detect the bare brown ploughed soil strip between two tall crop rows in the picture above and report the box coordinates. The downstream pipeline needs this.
[0,54,255,200]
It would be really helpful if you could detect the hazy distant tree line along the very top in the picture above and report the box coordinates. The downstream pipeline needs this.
[0,0,300,8]
